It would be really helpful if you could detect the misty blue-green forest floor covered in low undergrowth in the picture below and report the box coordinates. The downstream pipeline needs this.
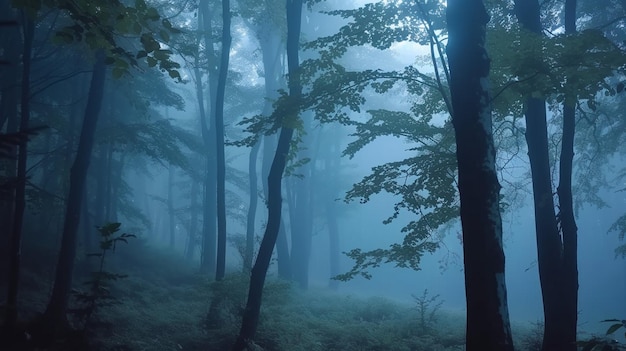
[0,239,540,351]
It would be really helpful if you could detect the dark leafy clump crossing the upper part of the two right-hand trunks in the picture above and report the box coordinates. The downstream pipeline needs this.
[489,27,626,115]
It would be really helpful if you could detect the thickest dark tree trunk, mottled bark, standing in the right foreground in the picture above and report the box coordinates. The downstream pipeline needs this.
[447,0,513,351]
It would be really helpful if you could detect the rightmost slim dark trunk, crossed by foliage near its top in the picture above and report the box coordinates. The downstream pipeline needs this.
[544,0,578,351]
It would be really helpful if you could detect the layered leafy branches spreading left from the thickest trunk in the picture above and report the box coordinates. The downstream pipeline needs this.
[290,1,458,280]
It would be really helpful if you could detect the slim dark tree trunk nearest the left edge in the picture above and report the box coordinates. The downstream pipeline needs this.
[5,16,35,332]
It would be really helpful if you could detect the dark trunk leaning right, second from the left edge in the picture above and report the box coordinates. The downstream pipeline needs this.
[42,52,106,337]
